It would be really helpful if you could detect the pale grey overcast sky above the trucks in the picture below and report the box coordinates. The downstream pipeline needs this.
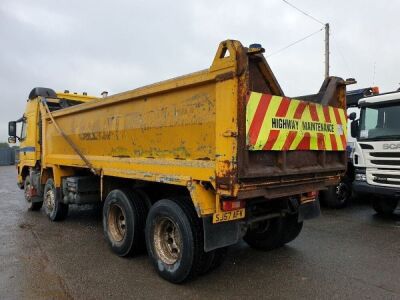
[0,0,400,142]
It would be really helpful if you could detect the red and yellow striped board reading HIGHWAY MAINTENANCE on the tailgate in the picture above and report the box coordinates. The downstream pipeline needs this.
[246,92,347,151]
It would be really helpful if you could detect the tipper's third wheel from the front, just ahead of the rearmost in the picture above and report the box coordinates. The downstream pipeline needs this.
[103,189,147,256]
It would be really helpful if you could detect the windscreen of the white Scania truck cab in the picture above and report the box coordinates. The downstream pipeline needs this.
[359,100,400,140]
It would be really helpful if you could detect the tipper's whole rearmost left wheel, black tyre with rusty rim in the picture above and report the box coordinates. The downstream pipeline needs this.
[146,199,207,283]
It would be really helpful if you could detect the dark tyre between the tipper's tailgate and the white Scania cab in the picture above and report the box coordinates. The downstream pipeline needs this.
[321,179,352,208]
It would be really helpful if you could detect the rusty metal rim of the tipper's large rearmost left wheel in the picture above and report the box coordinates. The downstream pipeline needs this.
[154,217,182,265]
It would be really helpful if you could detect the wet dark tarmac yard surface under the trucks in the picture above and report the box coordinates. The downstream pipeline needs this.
[0,166,400,299]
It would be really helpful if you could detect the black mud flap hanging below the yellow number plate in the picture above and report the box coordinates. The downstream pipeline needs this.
[203,216,242,252]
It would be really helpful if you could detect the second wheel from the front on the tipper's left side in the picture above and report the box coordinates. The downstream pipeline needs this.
[43,178,68,221]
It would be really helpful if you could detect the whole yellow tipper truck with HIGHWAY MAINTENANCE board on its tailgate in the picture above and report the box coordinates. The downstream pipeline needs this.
[9,40,347,283]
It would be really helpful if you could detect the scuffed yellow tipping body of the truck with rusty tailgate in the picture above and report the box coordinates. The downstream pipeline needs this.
[37,41,346,215]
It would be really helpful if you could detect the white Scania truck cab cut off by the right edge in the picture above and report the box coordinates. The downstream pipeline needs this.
[351,91,400,214]
